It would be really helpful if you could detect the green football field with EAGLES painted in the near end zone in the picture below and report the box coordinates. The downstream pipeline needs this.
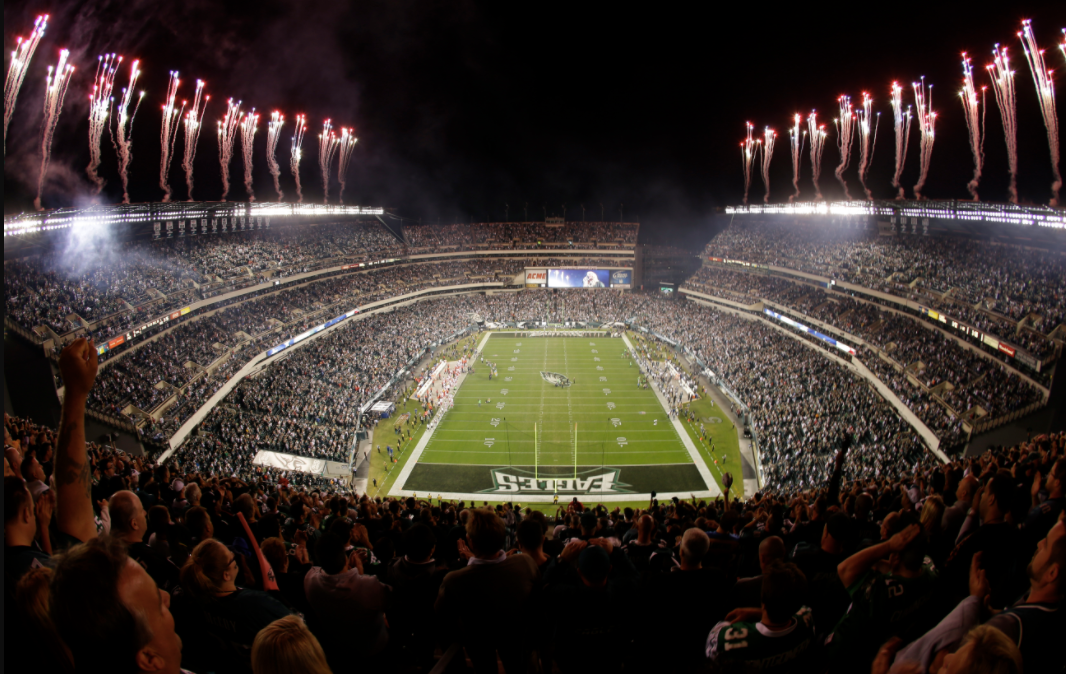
[391,335,720,501]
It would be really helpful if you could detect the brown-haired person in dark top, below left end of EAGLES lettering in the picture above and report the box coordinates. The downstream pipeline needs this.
[436,509,539,674]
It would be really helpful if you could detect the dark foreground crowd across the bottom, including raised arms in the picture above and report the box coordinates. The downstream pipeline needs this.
[4,341,1066,674]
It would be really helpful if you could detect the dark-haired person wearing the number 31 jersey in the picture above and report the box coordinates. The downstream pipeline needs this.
[706,561,814,674]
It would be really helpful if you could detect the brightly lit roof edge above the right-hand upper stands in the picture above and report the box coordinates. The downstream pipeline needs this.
[725,199,1066,236]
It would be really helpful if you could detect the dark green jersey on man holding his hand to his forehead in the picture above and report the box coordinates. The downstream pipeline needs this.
[825,558,937,664]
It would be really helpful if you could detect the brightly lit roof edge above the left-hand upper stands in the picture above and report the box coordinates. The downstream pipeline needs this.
[3,202,385,239]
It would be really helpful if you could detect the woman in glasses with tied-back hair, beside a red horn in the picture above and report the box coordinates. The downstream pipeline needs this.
[181,539,289,667]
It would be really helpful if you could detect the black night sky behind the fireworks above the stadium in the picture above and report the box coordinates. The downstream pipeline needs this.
[4,0,1066,247]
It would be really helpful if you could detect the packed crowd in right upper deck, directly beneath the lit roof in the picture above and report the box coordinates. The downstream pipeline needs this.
[705,222,1066,337]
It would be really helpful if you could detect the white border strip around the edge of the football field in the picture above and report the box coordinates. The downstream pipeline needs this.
[386,333,722,503]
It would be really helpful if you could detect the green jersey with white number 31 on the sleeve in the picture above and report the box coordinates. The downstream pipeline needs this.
[707,606,814,674]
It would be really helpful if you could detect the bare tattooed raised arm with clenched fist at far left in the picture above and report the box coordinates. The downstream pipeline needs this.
[55,338,99,542]
